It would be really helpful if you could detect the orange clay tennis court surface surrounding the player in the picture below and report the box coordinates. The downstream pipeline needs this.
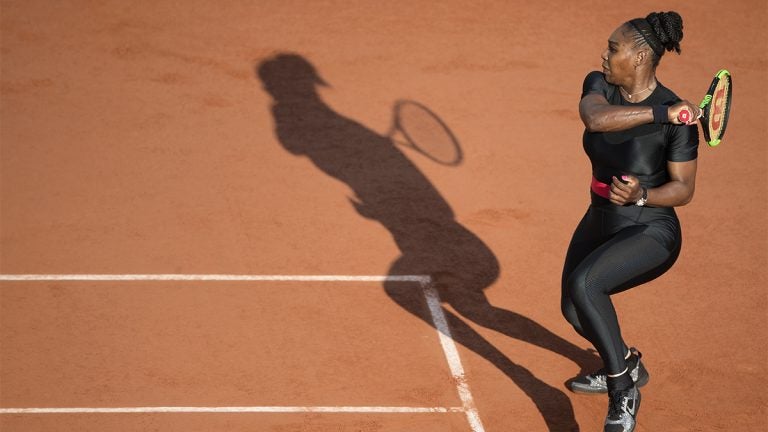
[0,0,768,432]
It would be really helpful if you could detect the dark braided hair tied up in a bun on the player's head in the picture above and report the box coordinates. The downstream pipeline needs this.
[627,11,683,67]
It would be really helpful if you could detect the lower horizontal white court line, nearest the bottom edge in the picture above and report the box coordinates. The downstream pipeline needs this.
[0,406,464,414]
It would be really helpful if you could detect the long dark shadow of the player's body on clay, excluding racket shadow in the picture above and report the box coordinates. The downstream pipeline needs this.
[256,54,596,431]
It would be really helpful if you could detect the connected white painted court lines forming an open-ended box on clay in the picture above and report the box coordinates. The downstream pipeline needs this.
[0,274,485,432]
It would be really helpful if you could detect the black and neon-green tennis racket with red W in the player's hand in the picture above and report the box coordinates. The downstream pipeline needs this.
[677,69,733,147]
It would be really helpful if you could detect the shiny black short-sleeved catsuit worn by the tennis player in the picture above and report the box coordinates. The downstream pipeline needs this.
[561,72,698,374]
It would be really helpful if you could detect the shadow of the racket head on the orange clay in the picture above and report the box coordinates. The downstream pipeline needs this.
[387,100,464,166]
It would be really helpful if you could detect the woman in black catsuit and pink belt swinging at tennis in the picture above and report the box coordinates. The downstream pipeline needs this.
[562,12,700,432]
